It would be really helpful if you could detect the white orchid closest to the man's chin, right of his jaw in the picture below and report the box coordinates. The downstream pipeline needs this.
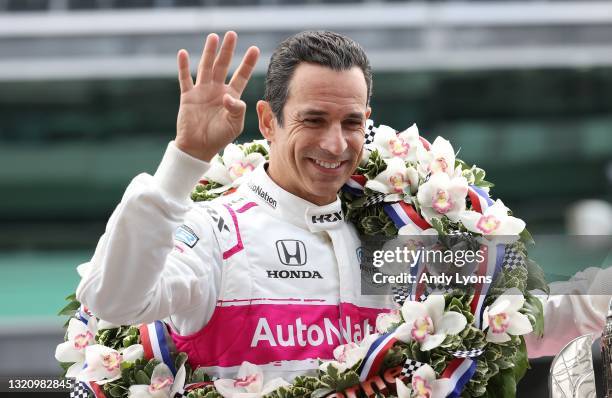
[365,158,419,202]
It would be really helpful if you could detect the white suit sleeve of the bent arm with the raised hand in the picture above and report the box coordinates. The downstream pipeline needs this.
[77,142,222,334]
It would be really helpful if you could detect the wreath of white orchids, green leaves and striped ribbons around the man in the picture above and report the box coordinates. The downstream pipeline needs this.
[55,120,548,398]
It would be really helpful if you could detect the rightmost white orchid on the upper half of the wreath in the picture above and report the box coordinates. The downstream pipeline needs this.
[459,199,525,243]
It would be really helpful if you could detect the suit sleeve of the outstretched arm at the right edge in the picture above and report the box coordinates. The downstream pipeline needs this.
[525,267,612,358]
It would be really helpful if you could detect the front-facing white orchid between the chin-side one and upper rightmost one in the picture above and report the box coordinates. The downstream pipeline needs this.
[417,173,468,223]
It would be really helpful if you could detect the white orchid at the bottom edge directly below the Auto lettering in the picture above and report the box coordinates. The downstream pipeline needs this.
[214,361,289,398]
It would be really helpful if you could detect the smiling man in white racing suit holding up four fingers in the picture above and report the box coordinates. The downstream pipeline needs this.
[77,32,390,380]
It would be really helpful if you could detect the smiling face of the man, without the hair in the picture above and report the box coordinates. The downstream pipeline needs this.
[258,63,370,205]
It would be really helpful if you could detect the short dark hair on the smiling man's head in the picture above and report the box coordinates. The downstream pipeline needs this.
[264,31,372,126]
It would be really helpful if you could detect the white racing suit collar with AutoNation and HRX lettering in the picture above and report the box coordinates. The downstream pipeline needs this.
[239,164,344,232]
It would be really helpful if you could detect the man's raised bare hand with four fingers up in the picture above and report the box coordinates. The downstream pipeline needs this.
[175,31,259,161]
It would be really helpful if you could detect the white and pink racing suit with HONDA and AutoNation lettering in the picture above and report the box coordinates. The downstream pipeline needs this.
[77,143,612,380]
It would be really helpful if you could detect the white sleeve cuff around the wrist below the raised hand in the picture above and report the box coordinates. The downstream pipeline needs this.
[154,141,210,202]
